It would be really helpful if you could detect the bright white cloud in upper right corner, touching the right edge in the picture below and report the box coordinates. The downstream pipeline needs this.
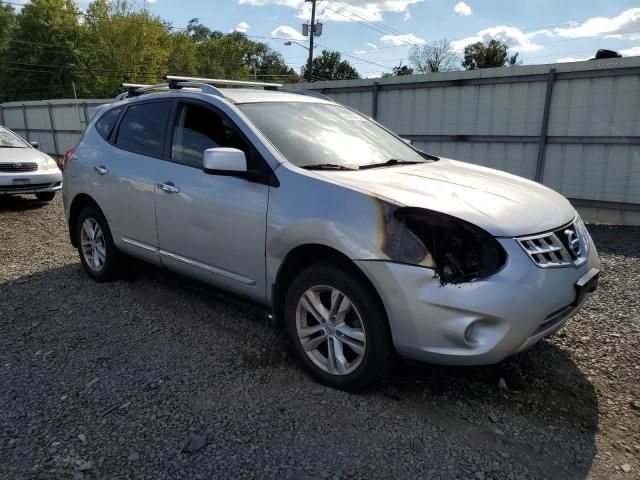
[555,8,640,40]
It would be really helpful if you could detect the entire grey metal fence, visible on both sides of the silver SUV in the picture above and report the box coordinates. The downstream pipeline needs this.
[0,58,640,225]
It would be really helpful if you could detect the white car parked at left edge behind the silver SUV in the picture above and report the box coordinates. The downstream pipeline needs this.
[0,126,62,202]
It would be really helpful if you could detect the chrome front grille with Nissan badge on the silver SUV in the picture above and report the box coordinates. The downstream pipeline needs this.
[516,217,589,268]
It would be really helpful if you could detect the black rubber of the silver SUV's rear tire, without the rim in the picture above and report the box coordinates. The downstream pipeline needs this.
[75,205,120,283]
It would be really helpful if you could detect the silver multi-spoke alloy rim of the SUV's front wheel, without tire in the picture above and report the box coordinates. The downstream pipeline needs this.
[296,285,366,375]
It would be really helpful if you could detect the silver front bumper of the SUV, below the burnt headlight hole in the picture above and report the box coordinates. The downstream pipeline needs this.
[357,234,600,365]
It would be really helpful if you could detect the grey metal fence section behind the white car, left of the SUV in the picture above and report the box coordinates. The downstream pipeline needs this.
[0,100,110,155]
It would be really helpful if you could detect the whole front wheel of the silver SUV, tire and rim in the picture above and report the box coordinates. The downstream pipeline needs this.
[284,262,395,392]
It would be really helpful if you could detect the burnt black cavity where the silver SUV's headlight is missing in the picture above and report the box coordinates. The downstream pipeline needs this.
[383,203,507,285]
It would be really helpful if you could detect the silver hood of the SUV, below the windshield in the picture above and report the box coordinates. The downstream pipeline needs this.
[317,159,576,237]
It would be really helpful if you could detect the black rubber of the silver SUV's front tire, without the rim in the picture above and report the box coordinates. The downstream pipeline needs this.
[284,262,397,392]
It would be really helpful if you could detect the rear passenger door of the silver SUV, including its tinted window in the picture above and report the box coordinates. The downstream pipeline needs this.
[91,100,173,263]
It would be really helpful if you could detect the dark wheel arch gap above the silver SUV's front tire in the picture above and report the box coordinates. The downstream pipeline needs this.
[271,243,388,321]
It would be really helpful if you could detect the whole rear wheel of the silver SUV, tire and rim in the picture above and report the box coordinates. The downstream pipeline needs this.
[75,205,120,282]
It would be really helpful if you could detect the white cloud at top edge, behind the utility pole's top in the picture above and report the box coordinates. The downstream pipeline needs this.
[238,0,424,22]
